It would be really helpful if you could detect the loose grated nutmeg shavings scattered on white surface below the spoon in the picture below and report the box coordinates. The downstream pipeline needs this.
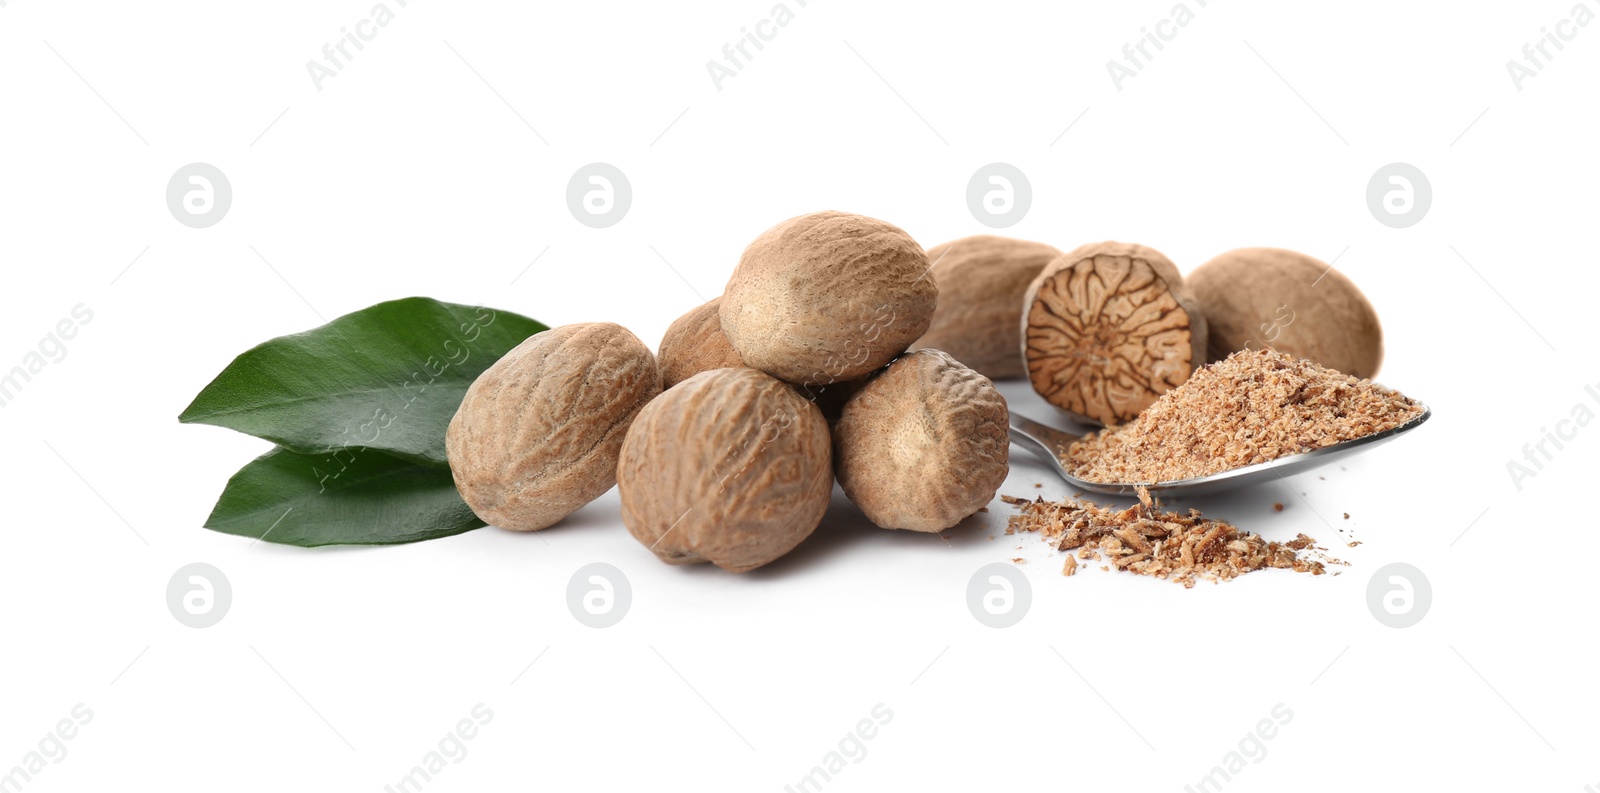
[1003,488,1342,588]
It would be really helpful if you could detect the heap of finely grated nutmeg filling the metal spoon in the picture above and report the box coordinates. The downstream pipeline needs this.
[1064,350,1422,483]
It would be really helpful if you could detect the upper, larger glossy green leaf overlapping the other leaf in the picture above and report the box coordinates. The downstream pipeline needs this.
[178,297,547,465]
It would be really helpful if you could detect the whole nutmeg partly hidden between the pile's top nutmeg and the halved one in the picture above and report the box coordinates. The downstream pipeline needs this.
[914,233,1061,379]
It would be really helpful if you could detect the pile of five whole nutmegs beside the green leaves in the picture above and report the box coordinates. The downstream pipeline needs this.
[446,211,1010,572]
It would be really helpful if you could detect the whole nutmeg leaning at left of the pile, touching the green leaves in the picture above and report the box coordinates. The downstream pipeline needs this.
[445,323,661,531]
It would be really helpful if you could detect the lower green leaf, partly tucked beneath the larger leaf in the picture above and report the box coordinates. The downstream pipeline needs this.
[205,449,483,547]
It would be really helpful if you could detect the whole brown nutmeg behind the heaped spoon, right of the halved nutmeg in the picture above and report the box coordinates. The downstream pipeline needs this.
[1189,248,1384,377]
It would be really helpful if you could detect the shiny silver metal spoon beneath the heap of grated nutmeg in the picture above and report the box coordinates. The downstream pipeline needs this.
[1011,406,1434,496]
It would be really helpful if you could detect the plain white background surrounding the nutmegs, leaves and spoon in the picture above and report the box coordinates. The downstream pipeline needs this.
[0,0,1600,793]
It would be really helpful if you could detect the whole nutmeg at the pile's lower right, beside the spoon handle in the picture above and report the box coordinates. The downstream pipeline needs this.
[834,350,1011,531]
